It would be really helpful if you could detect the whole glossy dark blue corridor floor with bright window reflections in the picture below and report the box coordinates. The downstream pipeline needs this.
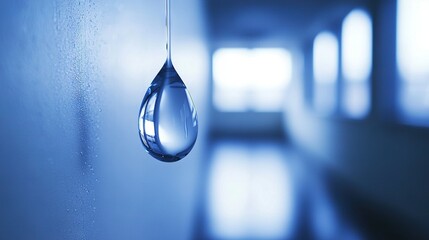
[195,139,423,240]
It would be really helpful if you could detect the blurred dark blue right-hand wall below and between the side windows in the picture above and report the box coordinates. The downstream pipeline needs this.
[284,1,429,229]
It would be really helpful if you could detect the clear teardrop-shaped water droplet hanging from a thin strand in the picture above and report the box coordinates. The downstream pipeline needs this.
[139,60,198,162]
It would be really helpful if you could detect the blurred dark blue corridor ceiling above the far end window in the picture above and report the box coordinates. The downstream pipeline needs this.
[206,0,370,46]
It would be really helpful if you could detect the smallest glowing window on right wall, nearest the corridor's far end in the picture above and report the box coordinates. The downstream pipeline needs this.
[313,32,338,113]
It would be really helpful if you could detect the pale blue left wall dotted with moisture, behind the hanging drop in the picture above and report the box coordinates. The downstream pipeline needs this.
[0,0,207,239]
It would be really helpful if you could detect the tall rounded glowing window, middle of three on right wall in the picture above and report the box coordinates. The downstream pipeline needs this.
[341,9,372,118]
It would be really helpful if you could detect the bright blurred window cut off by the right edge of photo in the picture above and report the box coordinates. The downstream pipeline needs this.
[397,0,429,120]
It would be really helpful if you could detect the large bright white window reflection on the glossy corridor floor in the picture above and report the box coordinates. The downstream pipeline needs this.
[208,143,294,239]
